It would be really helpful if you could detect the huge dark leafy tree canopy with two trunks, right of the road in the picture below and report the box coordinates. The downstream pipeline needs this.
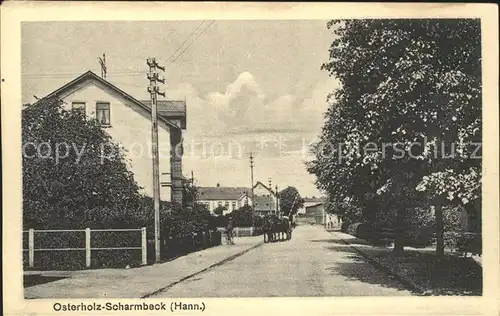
[308,19,481,255]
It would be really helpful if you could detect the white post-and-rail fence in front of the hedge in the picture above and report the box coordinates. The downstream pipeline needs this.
[23,227,147,268]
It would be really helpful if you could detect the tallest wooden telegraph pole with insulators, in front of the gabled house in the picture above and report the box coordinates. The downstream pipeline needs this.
[147,58,165,263]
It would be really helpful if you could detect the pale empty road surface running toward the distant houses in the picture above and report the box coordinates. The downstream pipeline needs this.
[156,226,411,297]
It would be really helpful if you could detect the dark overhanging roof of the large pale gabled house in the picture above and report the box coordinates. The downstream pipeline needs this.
[30,70,186,129]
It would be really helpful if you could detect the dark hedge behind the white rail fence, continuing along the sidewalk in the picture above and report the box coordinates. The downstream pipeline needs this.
[23,199,220,270]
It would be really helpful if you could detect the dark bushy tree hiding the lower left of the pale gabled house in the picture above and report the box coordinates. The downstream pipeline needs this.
[22,99,141,228]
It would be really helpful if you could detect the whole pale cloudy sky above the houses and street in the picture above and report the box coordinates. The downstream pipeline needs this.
[21,20,337,196]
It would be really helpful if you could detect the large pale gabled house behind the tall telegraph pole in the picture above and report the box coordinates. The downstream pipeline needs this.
[33,71,186,203]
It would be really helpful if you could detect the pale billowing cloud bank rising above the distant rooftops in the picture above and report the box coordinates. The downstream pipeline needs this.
[169,72,335,195]
